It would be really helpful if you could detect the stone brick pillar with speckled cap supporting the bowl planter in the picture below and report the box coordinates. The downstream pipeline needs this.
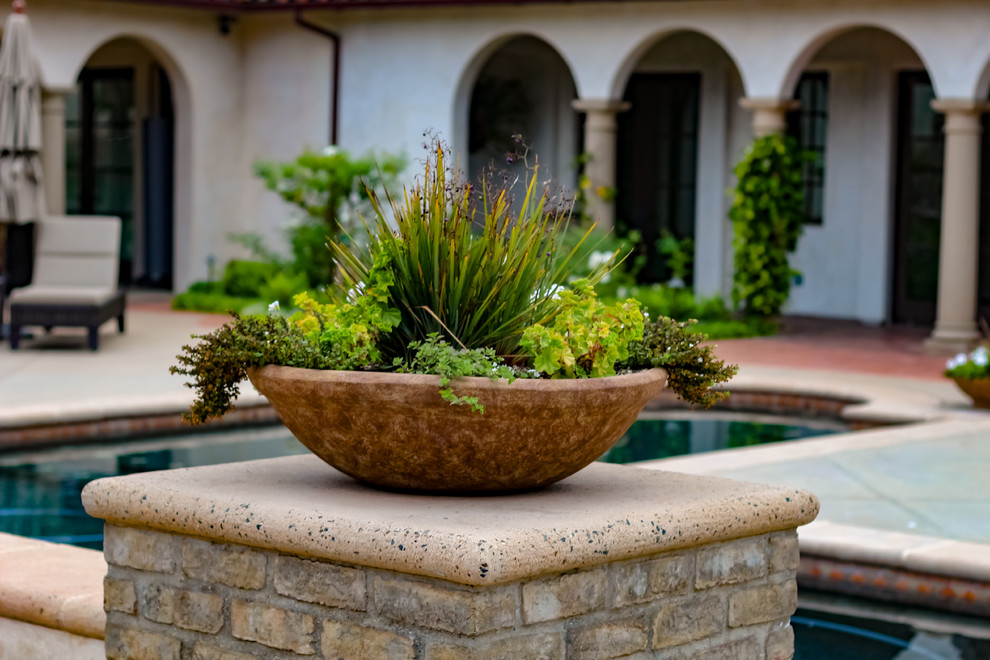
[83,456,818,660]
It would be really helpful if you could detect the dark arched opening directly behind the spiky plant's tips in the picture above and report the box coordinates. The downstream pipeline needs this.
[467,36,579,192]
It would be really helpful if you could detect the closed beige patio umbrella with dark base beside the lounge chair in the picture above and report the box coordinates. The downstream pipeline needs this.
[0,0,45,336]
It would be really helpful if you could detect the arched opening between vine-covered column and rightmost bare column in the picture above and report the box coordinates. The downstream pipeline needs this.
[785,27,944,325]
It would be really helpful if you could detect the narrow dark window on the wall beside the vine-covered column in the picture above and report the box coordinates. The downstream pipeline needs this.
[787,71,828,225]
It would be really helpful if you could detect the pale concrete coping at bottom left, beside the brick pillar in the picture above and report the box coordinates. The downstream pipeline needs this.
[0,533,107,640]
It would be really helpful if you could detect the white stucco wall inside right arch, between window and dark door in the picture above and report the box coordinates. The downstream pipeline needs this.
[787,29,923,323]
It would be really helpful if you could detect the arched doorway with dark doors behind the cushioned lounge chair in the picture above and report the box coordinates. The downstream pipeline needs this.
[66,38,175,289]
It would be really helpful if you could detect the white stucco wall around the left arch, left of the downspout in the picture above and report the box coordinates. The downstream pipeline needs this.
[16,0,331,290]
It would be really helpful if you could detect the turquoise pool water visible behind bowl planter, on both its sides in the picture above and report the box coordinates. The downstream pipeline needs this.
[0,412,842,549]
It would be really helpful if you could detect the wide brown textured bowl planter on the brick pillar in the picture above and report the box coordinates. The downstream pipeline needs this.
[248,366,667,493]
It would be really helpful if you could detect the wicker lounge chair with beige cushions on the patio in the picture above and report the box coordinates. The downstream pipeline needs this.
[10,216,124,351]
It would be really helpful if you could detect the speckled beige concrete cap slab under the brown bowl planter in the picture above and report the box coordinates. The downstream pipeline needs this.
[83,456,818,585]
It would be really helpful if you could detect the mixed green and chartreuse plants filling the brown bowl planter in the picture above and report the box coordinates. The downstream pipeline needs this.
[172,144,734,424]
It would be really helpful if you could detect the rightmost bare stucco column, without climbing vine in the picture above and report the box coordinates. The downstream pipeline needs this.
[926,99,988,351]
